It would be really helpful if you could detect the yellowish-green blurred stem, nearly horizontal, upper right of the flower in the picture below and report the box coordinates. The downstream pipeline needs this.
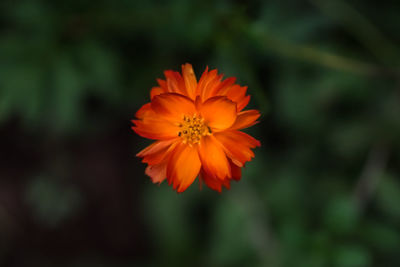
[251,26,400,78]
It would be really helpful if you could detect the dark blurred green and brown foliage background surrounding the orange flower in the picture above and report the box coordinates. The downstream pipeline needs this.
[0,0,400,267]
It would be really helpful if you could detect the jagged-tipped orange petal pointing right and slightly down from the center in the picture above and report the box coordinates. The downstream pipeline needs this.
[214,131,260,167]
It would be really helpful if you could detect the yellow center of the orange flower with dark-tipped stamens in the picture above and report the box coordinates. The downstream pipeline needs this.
[178,114,212,144]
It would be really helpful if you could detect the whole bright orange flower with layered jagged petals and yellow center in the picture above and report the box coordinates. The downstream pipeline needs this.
[132,64,260,192]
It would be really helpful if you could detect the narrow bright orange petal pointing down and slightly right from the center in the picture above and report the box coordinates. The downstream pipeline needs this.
[199,136,231,180]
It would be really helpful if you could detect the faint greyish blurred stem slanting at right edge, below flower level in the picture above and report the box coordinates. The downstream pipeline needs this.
[354,143,389,211]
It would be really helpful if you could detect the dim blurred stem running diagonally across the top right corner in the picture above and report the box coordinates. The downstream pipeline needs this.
[309,0,399,65]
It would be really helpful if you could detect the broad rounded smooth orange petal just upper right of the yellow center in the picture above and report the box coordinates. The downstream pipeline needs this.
[198,96,236,131]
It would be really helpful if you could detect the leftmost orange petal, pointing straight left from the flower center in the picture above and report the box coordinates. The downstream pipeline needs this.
[132,116,180,140]
